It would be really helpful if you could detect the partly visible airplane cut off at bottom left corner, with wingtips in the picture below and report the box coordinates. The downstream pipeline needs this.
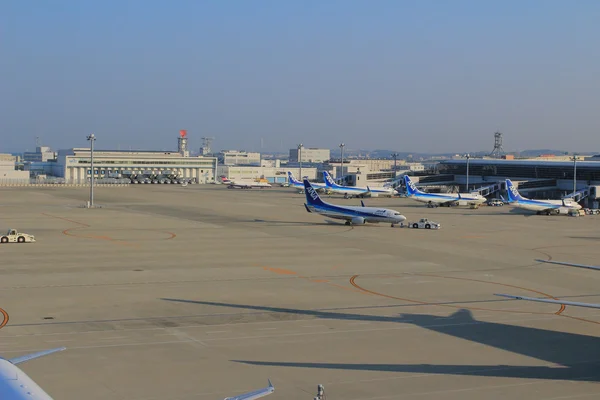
[0,347,275,400]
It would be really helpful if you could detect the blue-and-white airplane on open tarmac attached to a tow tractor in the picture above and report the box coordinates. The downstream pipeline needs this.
[304,179,406,228]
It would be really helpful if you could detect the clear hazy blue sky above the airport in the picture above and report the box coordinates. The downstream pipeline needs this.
[0,0,600,152]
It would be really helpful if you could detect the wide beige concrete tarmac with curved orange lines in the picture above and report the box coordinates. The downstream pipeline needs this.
[0,185,600,400]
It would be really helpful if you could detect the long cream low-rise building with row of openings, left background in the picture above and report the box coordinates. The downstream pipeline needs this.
[53,148,217,183]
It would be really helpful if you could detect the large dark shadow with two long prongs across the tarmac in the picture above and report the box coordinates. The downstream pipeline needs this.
[162,298,600,382]
